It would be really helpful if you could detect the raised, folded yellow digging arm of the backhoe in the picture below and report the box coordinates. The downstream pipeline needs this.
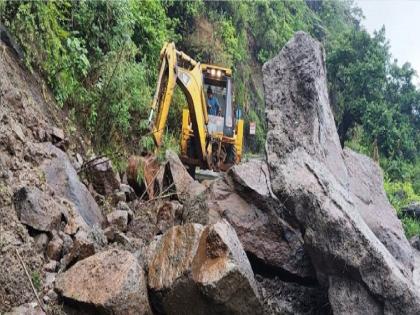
[149,43,208,161]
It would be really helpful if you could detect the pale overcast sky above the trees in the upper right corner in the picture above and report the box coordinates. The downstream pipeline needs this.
[355,0,420,87]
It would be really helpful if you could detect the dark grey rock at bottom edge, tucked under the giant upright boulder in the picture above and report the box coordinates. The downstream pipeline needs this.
[328,277,384,315]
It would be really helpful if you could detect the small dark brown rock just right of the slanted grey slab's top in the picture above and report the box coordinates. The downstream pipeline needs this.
[86,157,120,196]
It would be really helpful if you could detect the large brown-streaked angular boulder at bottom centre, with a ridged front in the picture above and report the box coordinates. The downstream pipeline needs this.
[148,221,262,314]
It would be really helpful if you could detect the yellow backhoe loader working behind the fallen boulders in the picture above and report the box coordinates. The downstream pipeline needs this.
[149,43,243,175]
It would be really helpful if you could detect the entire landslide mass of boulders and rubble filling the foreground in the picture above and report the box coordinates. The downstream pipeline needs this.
[0,33,420,314]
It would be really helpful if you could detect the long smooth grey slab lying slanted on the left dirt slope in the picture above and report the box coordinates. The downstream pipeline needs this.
[40,144,104,227]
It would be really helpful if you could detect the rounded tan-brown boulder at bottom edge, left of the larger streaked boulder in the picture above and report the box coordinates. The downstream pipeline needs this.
[55,249,152,315]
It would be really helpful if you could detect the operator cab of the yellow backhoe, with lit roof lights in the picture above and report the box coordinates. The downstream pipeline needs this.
[203,65,234,137]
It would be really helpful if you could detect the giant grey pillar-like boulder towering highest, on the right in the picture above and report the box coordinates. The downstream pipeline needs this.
[263,32,420,314]
